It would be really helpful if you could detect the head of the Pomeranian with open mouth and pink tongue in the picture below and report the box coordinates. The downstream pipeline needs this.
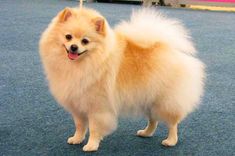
[40,8,108,60]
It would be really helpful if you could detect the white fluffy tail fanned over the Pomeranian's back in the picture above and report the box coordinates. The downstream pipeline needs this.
[115,8,196,54]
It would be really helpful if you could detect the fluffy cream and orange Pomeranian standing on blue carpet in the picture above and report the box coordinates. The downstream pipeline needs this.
[39,3,205,151]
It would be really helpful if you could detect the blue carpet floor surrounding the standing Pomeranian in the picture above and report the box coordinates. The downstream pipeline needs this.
[0,0,235,156]
